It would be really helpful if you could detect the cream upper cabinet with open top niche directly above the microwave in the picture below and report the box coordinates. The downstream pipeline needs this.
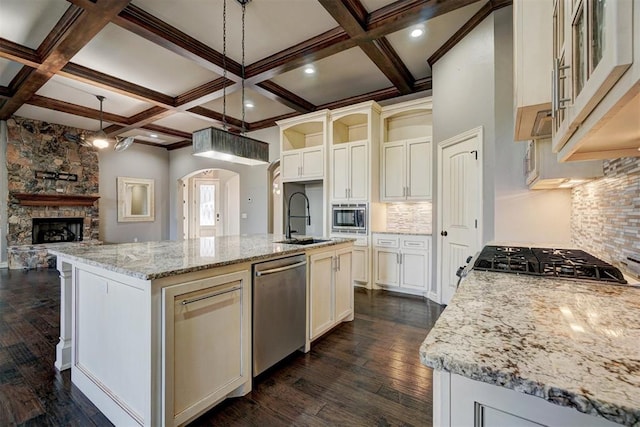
[329,101,380,203]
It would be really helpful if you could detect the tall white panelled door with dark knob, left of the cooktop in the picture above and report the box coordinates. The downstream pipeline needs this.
[437,128,482,304]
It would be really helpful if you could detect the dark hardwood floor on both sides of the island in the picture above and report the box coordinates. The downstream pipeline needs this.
[0,269,443,426]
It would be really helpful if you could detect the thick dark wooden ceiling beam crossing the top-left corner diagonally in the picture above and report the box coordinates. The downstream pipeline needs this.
[0,0,129,120]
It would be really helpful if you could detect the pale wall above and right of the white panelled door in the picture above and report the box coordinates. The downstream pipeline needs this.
[433,7,571,247]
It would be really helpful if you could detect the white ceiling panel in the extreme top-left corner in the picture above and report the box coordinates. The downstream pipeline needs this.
[0,0,70,49]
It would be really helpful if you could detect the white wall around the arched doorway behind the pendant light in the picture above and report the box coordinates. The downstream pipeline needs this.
[168,127,280,239]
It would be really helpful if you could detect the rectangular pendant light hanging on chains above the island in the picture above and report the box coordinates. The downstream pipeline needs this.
[192,0,269,166]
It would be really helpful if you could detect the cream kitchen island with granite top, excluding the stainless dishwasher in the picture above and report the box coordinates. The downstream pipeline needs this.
[51,235,353,426]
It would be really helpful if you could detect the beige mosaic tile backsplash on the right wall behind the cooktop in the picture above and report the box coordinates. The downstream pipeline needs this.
[571,157,640,276]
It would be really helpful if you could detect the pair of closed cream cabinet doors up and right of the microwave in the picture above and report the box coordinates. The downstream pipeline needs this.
[380,137,432,202]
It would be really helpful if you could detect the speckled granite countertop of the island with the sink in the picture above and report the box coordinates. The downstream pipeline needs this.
[49,234,354,280]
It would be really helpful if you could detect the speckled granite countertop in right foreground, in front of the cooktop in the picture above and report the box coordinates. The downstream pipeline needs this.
[420,270,640,426]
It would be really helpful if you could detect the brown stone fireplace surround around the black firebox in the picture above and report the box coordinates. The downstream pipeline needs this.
[7,116,99,251]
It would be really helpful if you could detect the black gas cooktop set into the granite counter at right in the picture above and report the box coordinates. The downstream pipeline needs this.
[473,246,627,283]
